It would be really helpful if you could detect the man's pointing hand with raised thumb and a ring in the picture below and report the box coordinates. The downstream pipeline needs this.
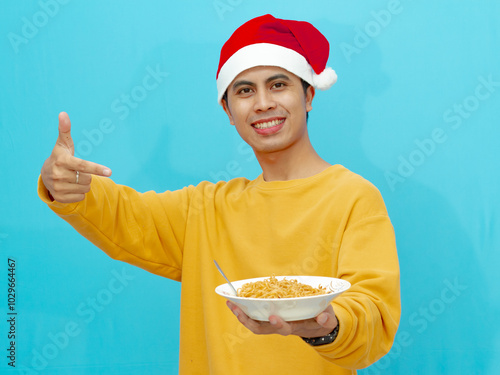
[41,112,111,203]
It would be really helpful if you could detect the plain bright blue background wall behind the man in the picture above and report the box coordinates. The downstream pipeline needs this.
[0,0,500,375]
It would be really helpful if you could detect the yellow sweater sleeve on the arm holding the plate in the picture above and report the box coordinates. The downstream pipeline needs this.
[316,184,401,369]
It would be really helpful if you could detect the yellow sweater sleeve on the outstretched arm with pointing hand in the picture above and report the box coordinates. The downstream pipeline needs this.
[38,176,193,280]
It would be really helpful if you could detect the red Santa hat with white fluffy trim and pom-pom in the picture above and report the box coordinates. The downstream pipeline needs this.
[217,14,337,103]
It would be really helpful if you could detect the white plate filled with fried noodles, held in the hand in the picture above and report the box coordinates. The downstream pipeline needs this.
[215,276,351,321]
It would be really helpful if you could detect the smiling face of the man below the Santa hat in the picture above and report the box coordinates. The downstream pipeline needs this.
[222,66,314,154]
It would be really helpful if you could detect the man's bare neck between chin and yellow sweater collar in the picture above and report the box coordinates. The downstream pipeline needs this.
[255,143,331,181]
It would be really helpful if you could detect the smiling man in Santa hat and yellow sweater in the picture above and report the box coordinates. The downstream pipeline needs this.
[39,15,400,375]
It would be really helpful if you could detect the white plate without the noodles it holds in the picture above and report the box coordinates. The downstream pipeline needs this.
[215,276,351,322]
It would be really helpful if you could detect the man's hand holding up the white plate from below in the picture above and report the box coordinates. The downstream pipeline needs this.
[227,301,338,337]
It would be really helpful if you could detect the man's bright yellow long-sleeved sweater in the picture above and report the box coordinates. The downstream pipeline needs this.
[39,165,400,375]
